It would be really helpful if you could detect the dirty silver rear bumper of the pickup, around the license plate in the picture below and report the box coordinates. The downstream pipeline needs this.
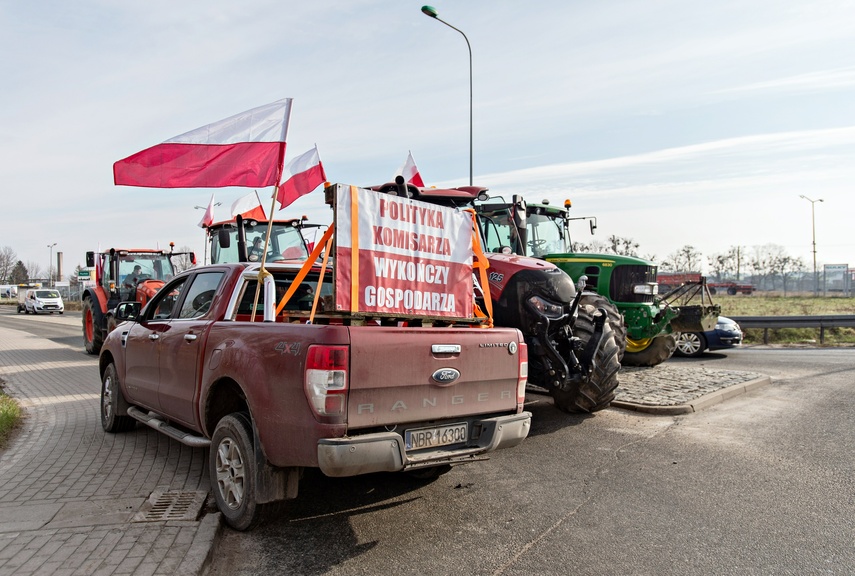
[318,412,531,477]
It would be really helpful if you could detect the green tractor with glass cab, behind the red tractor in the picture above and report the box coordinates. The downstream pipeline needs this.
[476,195,721,366]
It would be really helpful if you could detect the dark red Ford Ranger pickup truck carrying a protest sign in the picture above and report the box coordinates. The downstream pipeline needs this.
[99,263,531,530]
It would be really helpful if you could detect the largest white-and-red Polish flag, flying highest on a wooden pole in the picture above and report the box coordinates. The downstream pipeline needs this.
[113,98,291,188]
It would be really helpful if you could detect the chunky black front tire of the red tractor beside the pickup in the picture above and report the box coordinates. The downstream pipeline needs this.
[550,305,620,414]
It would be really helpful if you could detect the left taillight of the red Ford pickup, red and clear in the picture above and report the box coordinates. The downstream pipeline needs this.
[305,345,350,423]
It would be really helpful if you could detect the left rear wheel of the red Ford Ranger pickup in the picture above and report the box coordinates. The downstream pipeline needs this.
[208,412,272,531]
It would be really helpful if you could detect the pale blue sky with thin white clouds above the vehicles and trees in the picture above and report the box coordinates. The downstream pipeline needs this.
[0,0,855,280]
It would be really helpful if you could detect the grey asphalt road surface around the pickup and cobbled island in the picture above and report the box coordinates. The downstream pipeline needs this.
[0,307,855,576]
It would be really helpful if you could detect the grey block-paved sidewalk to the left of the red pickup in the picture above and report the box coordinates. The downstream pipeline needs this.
[0,328,219,576]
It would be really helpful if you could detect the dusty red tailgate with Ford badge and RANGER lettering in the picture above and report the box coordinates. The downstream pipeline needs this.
[347,326,522,430]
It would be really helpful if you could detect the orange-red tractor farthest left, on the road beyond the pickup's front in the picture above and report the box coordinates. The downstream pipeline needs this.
[83,244,196,354]
